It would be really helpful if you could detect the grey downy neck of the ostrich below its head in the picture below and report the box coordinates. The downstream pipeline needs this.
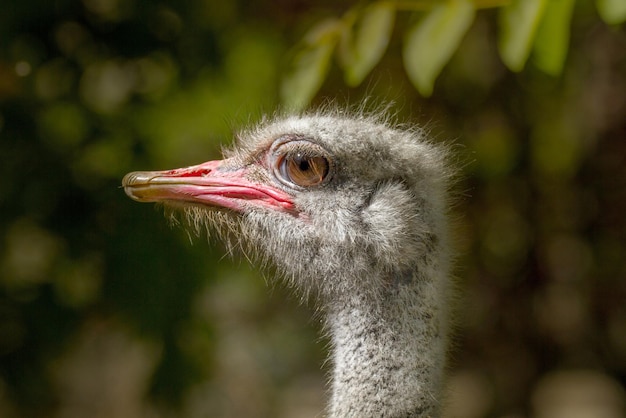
[327,274,445,418]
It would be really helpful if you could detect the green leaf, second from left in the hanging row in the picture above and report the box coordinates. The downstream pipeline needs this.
[339,3,395,86]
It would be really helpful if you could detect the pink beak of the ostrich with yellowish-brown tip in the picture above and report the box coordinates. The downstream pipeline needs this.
[122,160,296,213]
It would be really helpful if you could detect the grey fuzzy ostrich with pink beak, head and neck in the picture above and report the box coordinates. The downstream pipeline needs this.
[123,111,449,418]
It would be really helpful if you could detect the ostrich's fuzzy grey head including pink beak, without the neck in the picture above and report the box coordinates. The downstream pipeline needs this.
[123,115,446,302]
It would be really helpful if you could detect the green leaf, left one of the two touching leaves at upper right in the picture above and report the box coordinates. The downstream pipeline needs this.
[498,0,546,71]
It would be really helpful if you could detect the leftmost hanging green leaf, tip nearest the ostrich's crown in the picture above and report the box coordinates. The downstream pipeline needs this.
[280,20,343,110]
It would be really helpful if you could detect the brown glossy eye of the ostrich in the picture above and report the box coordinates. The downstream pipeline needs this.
[277,153,328,187]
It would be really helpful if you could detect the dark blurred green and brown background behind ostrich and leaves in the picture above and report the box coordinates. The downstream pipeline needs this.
[0,0,626,418]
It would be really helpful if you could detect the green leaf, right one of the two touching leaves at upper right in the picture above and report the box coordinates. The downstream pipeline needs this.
[533,0,572,76]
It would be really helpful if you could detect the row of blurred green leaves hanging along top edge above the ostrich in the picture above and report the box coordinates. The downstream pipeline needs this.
[281,0,626,109]
